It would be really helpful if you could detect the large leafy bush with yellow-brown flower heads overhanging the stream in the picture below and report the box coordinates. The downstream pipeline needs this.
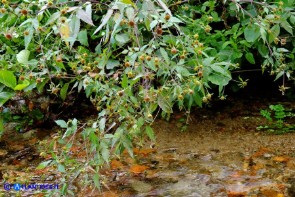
[0,0,295,193]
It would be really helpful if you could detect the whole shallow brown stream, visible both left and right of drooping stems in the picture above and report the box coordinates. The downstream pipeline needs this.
[0,97,295,197]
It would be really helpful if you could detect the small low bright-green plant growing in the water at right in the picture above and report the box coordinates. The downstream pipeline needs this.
[257,104,295,134]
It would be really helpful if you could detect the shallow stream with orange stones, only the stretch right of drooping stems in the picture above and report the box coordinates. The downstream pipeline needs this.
[102,99,295,197]
